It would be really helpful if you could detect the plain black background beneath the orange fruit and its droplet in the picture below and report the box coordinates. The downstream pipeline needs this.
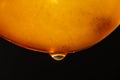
[0,27,120,80]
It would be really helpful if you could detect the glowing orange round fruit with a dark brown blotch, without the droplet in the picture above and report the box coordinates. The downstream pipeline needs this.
[0,0,120,53]
